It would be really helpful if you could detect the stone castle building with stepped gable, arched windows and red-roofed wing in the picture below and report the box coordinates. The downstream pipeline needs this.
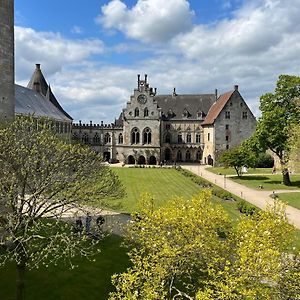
[72,75,256,165]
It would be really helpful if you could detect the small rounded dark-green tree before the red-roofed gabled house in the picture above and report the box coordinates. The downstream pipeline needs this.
[219,142,256,177]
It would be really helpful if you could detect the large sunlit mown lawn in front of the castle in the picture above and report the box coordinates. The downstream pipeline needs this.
[107,168,200,212]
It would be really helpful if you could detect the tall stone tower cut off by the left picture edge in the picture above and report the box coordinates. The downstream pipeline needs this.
[0,0,15,122]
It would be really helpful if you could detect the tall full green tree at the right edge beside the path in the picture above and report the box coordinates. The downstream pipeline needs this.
[252,75,300,185]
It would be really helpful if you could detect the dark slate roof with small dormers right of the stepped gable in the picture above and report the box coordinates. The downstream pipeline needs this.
[154,94,215,120]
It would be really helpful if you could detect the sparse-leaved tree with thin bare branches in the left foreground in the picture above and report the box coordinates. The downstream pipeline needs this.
[0,117,122,299]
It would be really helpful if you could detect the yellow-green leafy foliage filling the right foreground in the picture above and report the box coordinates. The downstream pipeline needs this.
[110,191,300,300]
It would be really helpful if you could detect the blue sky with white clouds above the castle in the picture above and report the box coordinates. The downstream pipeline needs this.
[15,0,300,123]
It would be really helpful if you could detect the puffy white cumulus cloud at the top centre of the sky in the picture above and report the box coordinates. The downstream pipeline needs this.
[96,0,194,42]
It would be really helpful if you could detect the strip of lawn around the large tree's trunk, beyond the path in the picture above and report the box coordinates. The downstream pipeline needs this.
[230,174,300,191]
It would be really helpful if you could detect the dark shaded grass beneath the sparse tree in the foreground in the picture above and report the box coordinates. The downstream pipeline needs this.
[0,236,130,300]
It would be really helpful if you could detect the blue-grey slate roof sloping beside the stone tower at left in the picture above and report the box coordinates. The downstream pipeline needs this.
[15,84,72,122]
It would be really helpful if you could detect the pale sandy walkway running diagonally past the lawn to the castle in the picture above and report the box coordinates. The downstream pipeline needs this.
[182,165,300,229]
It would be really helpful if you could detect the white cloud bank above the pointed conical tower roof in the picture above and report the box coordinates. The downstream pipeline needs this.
[15,26,105,80]
